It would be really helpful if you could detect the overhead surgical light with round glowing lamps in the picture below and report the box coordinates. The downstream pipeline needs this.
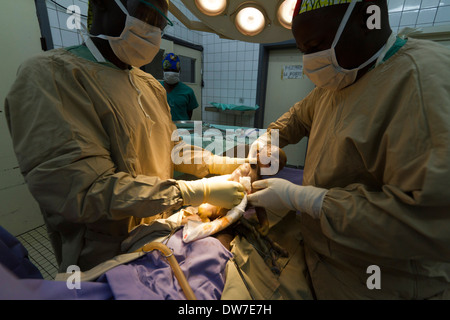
[173,0,296,43]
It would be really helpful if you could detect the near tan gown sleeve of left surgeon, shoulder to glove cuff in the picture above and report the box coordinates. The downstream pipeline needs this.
[5,57,183,223]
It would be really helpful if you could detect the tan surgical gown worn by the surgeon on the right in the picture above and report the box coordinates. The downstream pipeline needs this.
[270,39,450,299]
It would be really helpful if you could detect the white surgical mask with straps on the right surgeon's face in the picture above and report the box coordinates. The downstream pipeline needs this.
[303,0,385,90]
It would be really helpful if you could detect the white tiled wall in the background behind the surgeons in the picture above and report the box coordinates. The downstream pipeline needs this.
[47,0,450,126]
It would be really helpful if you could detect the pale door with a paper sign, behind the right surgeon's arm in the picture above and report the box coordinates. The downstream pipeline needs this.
[264,48,314,167]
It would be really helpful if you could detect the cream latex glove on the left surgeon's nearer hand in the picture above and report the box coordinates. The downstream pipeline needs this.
[177,178,244,209]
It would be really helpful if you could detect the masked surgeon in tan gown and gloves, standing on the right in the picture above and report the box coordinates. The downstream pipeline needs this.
[249,0,450,299]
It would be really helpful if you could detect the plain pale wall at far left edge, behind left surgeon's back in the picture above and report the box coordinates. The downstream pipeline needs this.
[0,0,43,235]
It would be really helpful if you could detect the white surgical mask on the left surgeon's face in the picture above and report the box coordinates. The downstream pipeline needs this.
[89,0,161,68]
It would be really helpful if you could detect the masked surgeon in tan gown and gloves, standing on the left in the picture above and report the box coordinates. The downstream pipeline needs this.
[5,0,244,272]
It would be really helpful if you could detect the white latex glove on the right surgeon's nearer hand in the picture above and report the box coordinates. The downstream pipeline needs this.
[247,178,328,219]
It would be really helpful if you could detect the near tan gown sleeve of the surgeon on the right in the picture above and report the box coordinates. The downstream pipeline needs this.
[320,53,450,261]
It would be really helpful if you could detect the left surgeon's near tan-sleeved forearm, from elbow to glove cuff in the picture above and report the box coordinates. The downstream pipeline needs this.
[26,157,182,223]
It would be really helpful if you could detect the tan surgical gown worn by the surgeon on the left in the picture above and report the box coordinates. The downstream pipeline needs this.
[5,47,207,272]
